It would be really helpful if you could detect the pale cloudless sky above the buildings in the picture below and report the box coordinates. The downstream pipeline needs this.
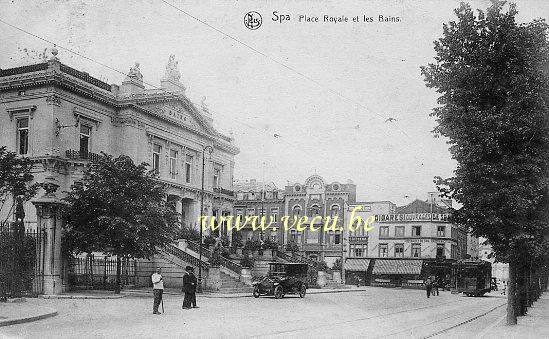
[0,0,549,205]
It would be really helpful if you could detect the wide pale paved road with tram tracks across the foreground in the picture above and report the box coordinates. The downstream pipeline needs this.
[0,288,505,338]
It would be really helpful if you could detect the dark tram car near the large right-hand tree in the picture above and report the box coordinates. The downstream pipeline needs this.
[452,260,492,297]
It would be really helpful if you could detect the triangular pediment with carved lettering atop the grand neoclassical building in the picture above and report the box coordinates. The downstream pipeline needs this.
[139,102,214,134]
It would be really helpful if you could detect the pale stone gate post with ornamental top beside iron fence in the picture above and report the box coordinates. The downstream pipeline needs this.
[32,178,65,295]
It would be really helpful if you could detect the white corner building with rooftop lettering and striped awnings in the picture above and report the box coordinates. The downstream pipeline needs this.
[344,199,467,286]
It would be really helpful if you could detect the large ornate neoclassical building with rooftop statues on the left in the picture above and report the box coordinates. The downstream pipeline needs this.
[0,49,239,227]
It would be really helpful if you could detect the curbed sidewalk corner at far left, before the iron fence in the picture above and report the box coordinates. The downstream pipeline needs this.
[0,302,57,327]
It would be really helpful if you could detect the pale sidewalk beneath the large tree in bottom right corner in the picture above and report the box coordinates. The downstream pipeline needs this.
[478,291,549,338]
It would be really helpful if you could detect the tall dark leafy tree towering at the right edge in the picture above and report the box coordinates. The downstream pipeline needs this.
[422,0,549,324]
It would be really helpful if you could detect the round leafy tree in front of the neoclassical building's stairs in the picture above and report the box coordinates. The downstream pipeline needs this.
[63,154,178,293]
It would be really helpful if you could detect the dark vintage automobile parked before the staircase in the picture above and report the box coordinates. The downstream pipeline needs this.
[252,263,309,299]
